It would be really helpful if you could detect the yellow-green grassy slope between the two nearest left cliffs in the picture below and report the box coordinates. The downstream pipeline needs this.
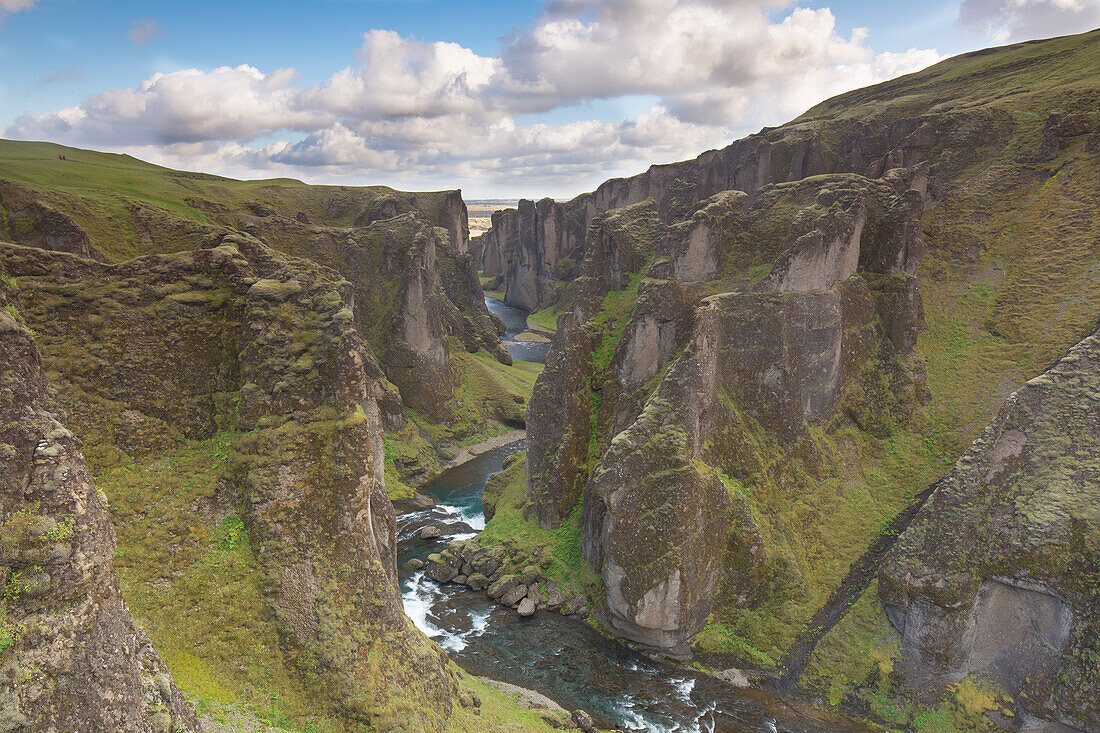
[96,434,342,731]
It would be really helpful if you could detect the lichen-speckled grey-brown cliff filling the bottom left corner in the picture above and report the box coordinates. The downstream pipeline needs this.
[0,266,198,733]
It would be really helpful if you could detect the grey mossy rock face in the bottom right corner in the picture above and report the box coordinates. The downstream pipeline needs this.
[879,325,1100,730]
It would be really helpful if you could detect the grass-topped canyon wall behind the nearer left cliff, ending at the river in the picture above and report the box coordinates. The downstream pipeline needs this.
[0,141,524,497]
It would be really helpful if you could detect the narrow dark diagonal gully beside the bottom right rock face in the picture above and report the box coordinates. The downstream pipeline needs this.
[777,481,941,691]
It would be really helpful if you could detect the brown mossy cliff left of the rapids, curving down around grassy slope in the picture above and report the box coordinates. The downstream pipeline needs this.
[0,234,452,730]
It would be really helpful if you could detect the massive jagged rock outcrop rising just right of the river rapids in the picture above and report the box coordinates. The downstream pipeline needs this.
[527,171,923,656]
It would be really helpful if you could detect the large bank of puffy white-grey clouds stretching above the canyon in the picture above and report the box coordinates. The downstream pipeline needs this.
[0,0,941,195]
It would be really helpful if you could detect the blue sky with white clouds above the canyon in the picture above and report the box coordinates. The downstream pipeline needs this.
[0,0,1100,199]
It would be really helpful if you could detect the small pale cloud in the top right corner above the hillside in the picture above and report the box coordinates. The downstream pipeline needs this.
[959,0,1100,42]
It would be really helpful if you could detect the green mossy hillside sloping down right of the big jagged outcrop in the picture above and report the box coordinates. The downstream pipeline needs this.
[490,31,1100,731]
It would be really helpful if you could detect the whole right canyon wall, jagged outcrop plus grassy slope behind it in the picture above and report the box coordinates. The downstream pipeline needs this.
[488,27,1100,722]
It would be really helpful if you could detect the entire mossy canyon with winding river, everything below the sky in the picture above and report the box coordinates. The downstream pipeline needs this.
[0,22,1100,732]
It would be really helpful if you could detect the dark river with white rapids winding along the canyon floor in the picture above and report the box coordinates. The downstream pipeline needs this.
[397,300,870,733]
